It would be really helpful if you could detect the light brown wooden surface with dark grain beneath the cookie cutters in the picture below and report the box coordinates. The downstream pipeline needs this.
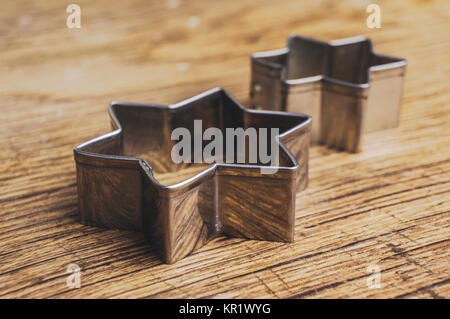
[0,0,450,298]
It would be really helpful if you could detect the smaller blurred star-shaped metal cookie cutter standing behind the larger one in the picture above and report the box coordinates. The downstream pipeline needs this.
[250,35,406,152]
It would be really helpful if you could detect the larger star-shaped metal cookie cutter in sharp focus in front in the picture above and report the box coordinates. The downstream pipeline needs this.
[74,88,311,263]
